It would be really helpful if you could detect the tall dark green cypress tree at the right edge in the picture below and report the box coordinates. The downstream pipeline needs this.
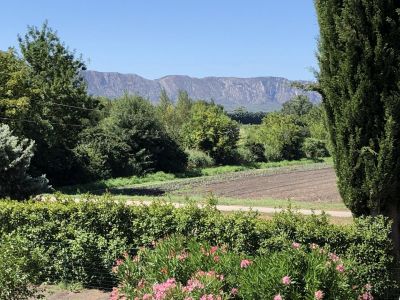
[315,0,400,253]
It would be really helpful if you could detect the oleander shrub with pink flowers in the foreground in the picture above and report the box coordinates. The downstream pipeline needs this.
[113,236,373,300]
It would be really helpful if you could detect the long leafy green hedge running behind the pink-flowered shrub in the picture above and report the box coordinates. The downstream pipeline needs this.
[0,196,394,295]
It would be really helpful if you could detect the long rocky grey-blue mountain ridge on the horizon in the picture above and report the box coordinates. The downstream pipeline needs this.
[83,71,321,111]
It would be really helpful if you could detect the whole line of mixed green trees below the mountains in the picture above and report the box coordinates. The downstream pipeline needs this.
[0,23,327,198]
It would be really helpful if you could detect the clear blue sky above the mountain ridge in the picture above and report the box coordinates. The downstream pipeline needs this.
[0,0,318,80]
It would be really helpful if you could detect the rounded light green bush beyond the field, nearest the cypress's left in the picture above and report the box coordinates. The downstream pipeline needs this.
[258,113,304,161]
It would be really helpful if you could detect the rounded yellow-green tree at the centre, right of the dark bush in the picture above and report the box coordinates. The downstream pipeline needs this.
[183,101,239,163]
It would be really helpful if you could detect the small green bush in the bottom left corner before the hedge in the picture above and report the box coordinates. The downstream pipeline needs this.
[0,235,44,300]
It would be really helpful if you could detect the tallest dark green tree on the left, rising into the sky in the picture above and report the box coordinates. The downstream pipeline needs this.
[15,23,98,185]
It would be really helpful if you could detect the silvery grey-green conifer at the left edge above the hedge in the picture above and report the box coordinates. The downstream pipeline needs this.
[0,124,49,199]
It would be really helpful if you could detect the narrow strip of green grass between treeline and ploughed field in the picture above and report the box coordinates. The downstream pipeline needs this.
[58,158,332,194]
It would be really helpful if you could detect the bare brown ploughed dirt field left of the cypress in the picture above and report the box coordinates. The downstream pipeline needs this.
[191,168,341,202]
